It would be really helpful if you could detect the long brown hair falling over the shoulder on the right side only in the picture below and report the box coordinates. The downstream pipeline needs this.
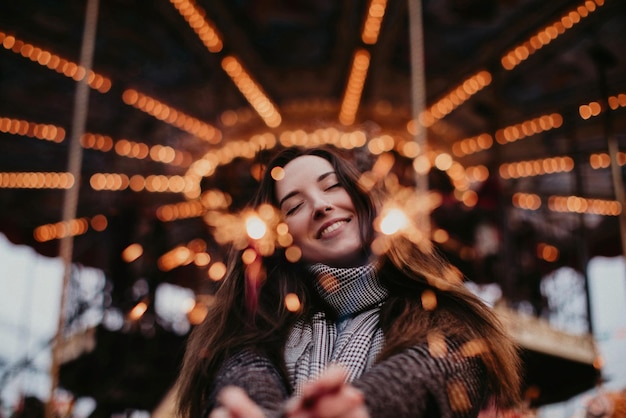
[378,236,521,408]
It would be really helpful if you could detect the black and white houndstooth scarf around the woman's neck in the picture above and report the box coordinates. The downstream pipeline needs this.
[285,264,387,394]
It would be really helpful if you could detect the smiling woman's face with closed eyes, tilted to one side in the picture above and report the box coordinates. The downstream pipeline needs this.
[276,155,364,267]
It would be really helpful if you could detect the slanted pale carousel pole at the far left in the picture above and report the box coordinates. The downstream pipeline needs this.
[46,0,99,418]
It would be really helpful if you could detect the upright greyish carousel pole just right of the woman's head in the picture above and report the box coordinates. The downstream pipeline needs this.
[407,0,430,233]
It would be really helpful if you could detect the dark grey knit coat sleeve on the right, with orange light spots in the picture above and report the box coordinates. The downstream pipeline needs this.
[353,344,486,418]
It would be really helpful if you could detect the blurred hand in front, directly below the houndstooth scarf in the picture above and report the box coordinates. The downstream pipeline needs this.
[285,366,369,418]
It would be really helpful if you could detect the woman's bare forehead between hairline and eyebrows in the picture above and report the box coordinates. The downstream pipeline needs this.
[276,155,335,199]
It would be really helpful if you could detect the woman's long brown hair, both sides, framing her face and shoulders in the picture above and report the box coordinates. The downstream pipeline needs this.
[178,147,520,417]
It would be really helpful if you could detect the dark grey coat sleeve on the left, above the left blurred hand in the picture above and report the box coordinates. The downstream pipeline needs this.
[203,350,289,417]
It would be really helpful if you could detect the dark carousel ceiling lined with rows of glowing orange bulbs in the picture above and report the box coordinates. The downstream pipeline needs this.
[0,0,626,412]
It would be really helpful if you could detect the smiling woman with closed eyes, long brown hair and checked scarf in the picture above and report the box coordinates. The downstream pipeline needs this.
[173,148,520,418]
